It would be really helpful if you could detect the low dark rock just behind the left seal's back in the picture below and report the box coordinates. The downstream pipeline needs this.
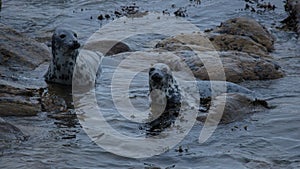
[84,40,131,56]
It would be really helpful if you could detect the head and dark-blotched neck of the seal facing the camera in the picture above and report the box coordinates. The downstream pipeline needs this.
[148,63,181,134]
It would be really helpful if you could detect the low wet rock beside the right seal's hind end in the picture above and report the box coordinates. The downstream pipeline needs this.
[197,93,267,125]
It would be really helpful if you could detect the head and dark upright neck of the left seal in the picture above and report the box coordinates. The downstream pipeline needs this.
[45,28,80,85]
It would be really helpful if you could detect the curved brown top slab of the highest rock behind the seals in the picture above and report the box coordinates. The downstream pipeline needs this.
[213,17,275,52]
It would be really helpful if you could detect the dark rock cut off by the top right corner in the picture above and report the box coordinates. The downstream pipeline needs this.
[282,0,300,34]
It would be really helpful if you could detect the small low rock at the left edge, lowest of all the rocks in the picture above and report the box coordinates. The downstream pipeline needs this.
[0,117,27,142]
